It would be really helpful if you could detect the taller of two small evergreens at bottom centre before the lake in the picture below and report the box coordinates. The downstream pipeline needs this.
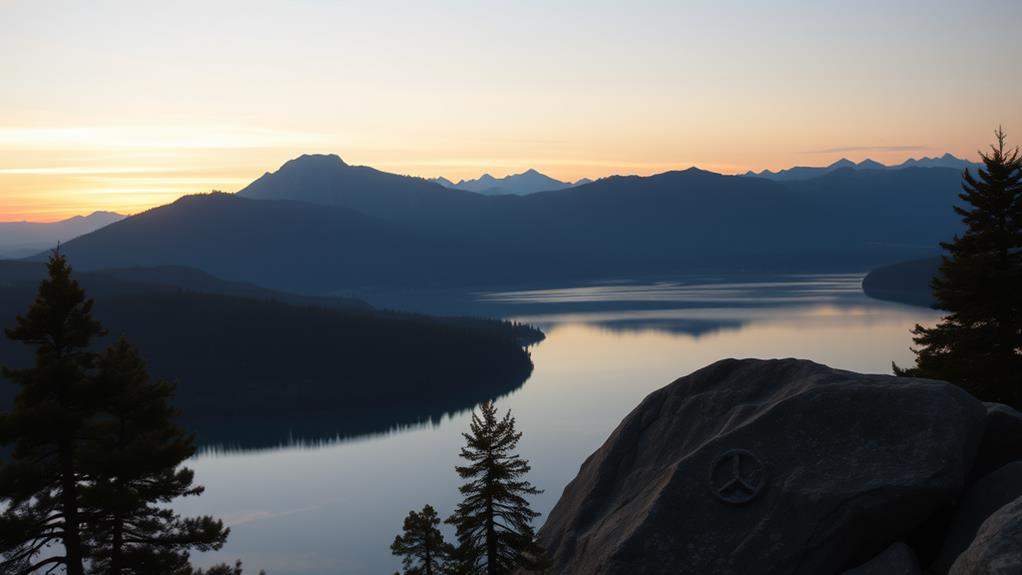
[448,401,546,575]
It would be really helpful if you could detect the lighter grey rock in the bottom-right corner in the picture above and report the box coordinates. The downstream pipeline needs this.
[949,497,1022,575]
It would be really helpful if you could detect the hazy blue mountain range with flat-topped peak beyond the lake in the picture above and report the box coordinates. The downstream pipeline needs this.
[51,155,961,294]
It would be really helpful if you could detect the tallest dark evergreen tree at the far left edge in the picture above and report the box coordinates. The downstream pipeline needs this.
[0,250,103,575]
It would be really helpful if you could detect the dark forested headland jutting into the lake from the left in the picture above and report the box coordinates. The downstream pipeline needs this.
[0,261,543,447]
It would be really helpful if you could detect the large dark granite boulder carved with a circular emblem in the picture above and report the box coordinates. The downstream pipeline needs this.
[539,360,985,575]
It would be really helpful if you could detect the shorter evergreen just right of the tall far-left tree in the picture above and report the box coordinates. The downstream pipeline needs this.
[82,339,230,575]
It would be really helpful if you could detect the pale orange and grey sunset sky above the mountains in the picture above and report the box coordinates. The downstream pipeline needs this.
[0,0,1022,222]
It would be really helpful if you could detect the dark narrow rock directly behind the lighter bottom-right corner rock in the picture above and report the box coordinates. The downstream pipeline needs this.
[928,462,1022,574]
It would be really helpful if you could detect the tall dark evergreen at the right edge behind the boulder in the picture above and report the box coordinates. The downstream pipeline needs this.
[894,129,1022,408]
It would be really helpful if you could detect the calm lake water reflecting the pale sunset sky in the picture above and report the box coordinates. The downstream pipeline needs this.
[178,274,938,575]
